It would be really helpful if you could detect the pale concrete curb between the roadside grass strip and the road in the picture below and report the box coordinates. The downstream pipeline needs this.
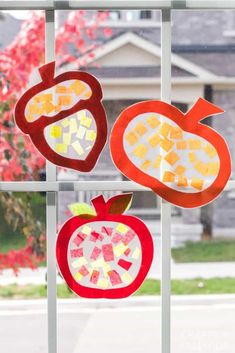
[0,294,235,310]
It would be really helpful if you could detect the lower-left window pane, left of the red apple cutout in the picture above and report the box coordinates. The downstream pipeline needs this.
[0,192,47,353]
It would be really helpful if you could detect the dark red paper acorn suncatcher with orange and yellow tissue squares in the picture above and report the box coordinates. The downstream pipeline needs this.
[15,62,107,172]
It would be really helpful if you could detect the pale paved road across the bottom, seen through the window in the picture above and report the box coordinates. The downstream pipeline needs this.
[0,301,235,353]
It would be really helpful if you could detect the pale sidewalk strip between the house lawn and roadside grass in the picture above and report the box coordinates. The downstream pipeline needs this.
[0,262,235,286]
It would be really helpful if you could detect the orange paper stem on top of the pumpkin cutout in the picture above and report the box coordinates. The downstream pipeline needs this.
[185,98,224,126]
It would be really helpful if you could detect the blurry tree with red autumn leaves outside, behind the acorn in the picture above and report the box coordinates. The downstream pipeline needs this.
[0,11,111,270]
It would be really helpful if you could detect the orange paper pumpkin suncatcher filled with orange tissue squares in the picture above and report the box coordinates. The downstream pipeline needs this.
[110,98,231,208]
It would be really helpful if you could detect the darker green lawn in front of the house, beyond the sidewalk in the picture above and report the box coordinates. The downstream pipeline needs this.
[172,240,235,262]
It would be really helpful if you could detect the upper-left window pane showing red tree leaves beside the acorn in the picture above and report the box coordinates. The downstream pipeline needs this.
[0,11,45,181]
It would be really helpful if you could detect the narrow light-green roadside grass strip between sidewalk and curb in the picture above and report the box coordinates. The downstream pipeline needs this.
[0,278,235,299]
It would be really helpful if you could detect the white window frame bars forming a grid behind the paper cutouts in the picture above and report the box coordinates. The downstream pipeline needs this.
[0,0,235,353]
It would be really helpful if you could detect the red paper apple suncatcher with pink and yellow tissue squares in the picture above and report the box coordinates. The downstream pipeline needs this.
[56,194,153,299]
